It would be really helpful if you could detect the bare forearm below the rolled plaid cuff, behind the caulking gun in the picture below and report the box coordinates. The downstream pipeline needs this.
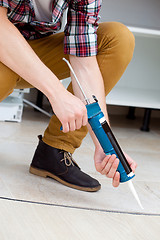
[70,56,109,148]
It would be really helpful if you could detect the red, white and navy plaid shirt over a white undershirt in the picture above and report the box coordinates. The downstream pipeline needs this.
[0,0,102,57]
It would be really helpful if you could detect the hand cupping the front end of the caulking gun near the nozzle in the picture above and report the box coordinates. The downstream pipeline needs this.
[94,148,137,187]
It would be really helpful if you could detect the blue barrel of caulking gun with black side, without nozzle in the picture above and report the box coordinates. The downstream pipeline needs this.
[86,101,135,182]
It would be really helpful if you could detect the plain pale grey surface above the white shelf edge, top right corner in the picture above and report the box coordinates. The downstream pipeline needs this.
[100,0,160,29]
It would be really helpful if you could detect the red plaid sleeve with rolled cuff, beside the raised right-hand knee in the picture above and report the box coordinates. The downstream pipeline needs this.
[64,0,102,57]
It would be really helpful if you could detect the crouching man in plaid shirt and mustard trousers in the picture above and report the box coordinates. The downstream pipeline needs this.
[0,0,136,191]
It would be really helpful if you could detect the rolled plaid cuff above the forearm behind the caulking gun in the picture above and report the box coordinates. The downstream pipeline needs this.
[64,34,97,57]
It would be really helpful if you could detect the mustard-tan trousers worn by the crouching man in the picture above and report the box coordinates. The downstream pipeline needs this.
[0,22,134,153]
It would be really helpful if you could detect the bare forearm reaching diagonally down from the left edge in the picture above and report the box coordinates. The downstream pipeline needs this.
[0,8,63,98]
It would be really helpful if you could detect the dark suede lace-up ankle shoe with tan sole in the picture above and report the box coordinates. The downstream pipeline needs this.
[29,136,101,192]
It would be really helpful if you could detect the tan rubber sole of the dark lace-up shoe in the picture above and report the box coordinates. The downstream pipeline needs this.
[29,166,101,192]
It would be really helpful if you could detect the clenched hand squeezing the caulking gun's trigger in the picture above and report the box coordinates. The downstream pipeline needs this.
[50,88,88,133]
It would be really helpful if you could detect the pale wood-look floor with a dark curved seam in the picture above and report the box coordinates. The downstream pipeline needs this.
[0,108,160,240]
